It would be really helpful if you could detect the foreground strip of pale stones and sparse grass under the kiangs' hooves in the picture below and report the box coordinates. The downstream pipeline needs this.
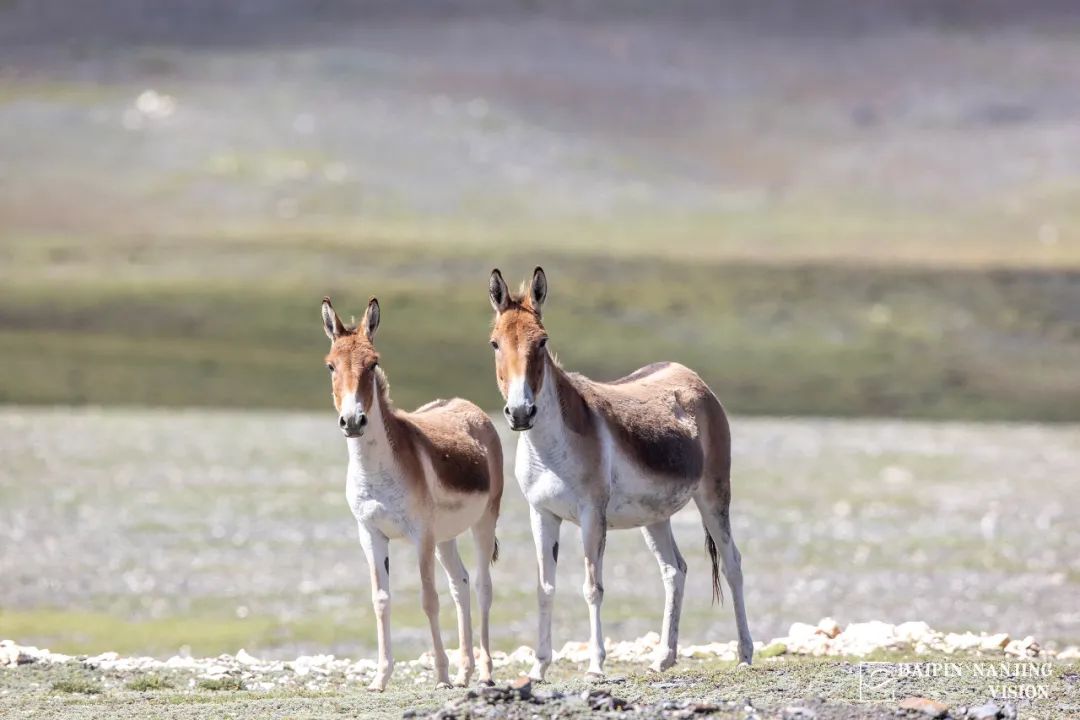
[0,620,1080,720]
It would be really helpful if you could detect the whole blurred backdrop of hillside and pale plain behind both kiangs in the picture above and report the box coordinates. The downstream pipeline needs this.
[0,0,1080,657]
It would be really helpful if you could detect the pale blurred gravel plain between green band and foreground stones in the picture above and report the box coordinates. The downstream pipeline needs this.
[0,408,1080,658]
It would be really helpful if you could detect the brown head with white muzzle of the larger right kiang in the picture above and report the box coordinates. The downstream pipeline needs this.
[487,268,548,431]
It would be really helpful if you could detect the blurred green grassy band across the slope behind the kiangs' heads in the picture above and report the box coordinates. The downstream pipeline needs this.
[0,234,1080,421]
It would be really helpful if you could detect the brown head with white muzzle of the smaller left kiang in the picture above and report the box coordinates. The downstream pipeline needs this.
[323,298,379,437]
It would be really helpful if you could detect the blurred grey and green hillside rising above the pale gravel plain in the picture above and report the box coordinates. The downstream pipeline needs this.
[0,0,1080,420]
